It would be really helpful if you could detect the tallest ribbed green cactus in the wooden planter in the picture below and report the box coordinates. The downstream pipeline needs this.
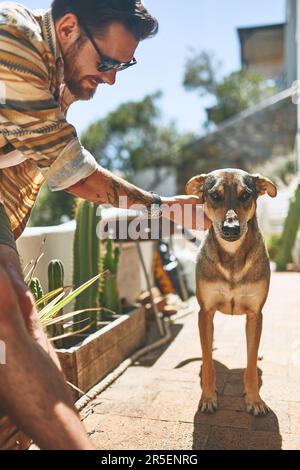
[73,200,100,333]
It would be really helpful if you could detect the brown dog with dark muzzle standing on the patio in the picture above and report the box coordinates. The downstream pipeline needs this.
[186,169,277,416]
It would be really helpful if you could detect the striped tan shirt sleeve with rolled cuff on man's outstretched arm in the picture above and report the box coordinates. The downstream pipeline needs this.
[0,9,98,191]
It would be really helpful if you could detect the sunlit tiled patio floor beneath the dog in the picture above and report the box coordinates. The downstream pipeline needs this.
[83,273,300,450]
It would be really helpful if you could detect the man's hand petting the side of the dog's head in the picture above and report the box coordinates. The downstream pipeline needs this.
[161,196,211,230]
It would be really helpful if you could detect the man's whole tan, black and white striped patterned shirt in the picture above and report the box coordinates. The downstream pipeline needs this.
[0,2,98,239]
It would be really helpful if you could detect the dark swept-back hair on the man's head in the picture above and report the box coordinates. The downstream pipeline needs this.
[51,0,158,41]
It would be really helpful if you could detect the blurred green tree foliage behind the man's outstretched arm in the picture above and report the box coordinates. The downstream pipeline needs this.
[81,92,191,178]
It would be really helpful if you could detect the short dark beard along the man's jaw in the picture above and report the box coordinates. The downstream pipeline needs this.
[64,48,97,101]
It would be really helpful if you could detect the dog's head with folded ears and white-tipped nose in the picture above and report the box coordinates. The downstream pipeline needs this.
[185,169,277,242]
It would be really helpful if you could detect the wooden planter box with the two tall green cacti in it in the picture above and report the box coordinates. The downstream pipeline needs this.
[57,200,146,398]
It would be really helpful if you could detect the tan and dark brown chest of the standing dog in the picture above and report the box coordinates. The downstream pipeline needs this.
[196,229,270,315]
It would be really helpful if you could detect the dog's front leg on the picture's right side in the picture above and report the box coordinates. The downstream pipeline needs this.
[244,313,268,416]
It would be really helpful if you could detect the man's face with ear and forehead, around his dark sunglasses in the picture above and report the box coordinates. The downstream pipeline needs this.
[55,13,138,100]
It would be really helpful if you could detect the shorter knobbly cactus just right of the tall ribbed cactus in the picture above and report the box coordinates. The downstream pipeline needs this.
[100,238,121,315]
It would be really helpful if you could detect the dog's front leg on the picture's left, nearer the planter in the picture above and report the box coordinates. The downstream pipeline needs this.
[199,309,218,413]
